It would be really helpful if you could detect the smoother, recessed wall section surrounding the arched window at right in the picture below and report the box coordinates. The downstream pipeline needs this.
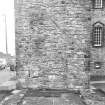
[90,5,105,76]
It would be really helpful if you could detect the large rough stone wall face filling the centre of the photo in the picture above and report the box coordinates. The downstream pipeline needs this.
[15,0,91,88]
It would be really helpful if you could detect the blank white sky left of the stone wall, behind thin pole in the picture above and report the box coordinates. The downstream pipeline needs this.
[0,0,15,56]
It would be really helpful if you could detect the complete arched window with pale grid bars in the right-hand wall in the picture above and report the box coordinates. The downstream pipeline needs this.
[92,22,104,47]
